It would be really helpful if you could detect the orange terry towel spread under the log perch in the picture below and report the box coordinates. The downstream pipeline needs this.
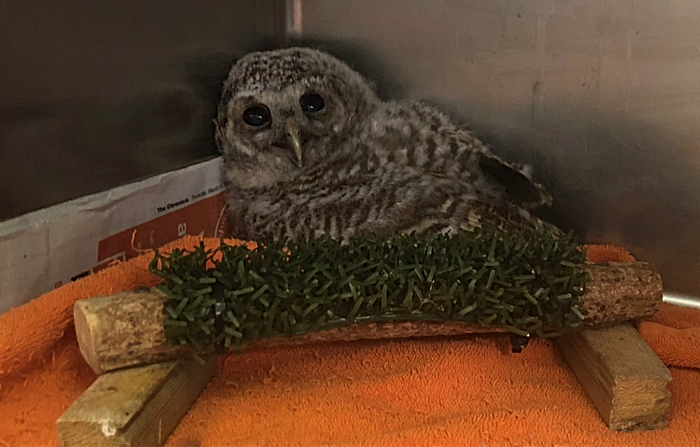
[0,238,700,447]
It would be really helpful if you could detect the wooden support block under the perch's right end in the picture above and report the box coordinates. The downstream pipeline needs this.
[555,324,671,431]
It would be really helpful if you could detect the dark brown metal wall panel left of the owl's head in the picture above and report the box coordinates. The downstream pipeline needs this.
[0,0,284,219]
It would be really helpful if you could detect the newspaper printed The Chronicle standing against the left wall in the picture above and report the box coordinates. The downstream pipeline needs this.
[0,158,226,314]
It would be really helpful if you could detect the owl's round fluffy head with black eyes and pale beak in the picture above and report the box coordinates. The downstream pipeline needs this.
[215,48,379,188]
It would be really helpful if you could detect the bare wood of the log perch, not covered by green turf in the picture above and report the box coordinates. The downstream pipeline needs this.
[74,262,662,374]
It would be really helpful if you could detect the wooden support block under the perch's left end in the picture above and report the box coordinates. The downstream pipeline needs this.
[56,357,217,447]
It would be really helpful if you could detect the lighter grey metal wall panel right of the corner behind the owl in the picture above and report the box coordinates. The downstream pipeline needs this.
[292,0,700,296]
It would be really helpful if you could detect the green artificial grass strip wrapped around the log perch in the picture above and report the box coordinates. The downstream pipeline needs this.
[150,232,587,353]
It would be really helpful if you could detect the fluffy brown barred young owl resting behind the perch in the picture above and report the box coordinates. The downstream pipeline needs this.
[215,48,557,241]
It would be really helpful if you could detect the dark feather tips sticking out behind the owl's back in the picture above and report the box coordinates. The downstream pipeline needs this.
[479,153,552,209]
